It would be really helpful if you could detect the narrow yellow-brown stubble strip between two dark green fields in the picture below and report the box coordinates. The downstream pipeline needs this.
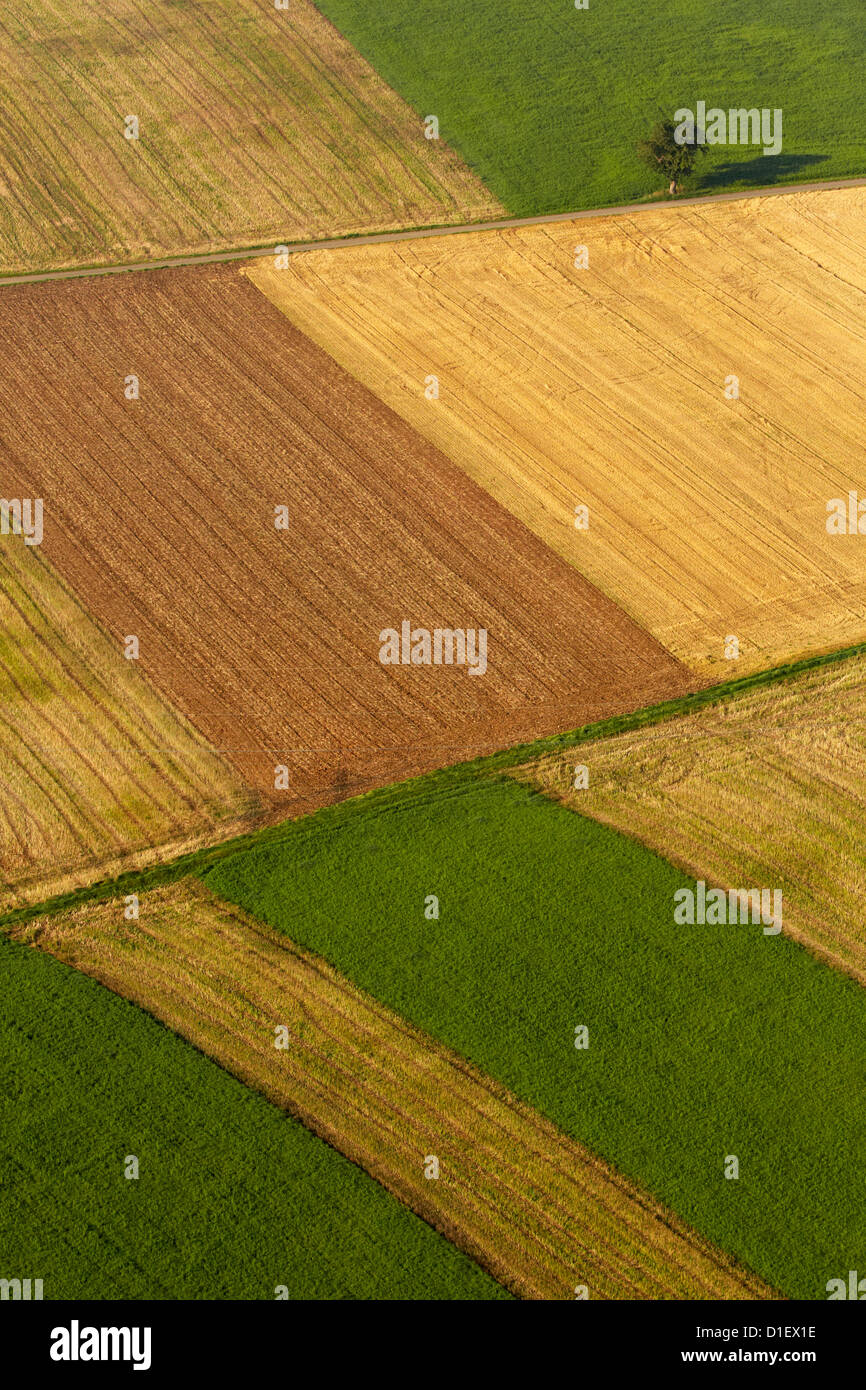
[15,880,773,1298]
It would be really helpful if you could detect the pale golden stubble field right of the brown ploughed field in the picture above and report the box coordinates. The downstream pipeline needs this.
[249,189,866,678]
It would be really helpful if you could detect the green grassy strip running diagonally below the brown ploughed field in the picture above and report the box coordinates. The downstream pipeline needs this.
[0,642,866,931]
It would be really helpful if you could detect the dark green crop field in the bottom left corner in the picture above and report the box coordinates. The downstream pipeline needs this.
[0,940,507,1298]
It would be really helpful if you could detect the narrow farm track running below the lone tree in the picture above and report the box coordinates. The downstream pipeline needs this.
[0,178,866,289]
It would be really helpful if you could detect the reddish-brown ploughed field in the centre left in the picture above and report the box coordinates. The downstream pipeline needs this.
[0,267,694,810]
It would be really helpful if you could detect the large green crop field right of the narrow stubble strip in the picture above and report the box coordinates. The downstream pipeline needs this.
[206,774,866,1298]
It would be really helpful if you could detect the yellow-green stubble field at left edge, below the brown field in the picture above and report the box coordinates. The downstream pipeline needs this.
[0,535,259,909]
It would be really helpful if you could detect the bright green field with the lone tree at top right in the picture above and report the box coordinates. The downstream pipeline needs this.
[317,0,866,215]
